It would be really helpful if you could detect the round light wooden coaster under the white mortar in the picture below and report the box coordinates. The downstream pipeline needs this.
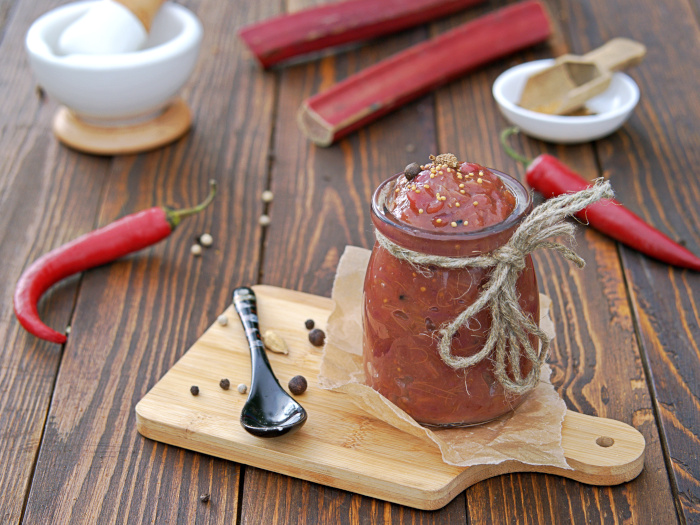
[53,98,192,155]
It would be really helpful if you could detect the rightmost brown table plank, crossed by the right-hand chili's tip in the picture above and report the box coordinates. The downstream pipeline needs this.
[552,0,700,523]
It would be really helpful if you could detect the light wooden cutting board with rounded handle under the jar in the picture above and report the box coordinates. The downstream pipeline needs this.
[136,286,645,510]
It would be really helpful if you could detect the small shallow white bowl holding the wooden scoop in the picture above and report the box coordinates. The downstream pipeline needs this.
[493,59,639,144]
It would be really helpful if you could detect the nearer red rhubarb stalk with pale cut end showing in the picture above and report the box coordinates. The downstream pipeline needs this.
[297,0,551,146]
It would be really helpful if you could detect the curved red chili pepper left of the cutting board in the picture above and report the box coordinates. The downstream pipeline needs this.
[14,180,216,344]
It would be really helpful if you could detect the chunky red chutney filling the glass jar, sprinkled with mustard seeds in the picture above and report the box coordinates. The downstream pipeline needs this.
[363,157,539,427]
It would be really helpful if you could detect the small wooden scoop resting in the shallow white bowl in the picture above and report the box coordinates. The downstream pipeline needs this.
[520,38,646,115]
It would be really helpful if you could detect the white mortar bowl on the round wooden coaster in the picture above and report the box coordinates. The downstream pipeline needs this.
[25,0,202,125]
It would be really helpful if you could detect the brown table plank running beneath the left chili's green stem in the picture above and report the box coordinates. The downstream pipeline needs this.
[20,1,275,523]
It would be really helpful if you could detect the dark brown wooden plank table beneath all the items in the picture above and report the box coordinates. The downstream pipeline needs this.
[0,0,700,524]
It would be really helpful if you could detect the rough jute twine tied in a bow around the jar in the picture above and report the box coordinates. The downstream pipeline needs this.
[375,179,613,394]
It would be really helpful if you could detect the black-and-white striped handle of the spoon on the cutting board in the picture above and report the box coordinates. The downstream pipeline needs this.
[233,286,279,396]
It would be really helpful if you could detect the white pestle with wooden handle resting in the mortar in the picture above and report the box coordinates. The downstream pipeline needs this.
[58,0,164,55]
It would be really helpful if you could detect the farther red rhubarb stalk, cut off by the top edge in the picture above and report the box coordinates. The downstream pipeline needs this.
[239,0,485,68]
